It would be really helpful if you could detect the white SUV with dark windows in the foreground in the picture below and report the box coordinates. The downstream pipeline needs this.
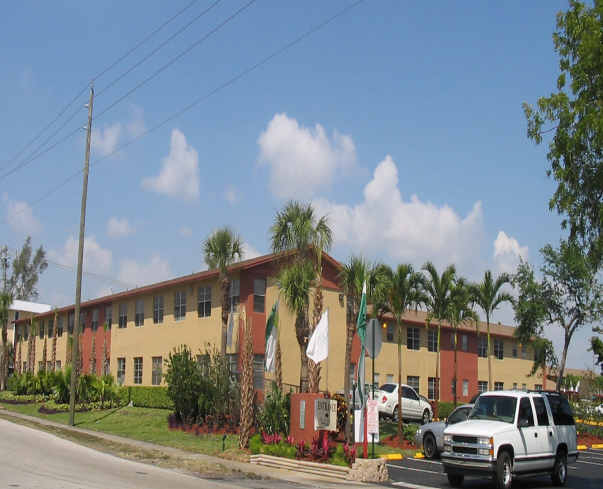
[442,391,578,489]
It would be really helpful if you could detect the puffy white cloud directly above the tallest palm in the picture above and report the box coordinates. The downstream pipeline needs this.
[258,114,356,198]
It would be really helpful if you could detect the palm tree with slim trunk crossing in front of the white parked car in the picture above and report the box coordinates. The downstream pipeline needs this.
[386,264,427,440]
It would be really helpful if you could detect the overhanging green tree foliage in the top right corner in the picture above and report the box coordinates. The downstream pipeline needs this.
[523,0,603,268]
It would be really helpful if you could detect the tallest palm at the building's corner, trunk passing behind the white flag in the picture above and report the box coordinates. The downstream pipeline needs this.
[270,201,333,392]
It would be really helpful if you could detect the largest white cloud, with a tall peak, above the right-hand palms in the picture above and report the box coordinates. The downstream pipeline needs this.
[314,155,483,267]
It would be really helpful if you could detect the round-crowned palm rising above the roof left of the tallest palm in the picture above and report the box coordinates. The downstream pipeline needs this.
[203,227,243,355]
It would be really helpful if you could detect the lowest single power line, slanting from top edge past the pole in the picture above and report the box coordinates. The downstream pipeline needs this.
[2,0,364,214]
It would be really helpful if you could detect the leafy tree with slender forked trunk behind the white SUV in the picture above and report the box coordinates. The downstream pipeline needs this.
[513,241,603,390]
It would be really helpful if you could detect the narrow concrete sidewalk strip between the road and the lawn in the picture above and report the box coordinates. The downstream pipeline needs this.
[0,406,382,489]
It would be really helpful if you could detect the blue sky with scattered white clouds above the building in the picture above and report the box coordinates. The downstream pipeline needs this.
[0,0,590,367]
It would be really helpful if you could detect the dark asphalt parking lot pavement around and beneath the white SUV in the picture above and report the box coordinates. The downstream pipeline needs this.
[388,450,603,489]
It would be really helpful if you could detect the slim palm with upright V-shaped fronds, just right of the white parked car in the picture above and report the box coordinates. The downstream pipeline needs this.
[423,261,456,400]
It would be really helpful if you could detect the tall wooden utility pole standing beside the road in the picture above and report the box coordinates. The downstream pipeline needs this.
[69,85,94,426]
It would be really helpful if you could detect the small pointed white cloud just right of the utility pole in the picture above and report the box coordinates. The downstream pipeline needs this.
[142,129,199,200]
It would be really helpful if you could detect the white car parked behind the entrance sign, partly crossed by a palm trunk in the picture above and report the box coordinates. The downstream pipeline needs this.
[375,383,433,424]
